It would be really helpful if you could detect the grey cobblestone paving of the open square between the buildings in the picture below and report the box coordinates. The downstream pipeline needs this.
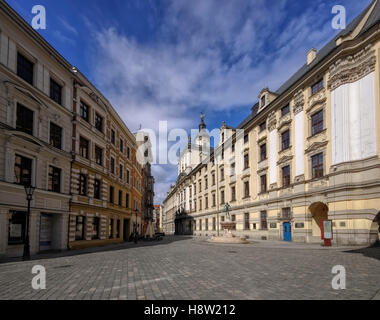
[0,237,380,300]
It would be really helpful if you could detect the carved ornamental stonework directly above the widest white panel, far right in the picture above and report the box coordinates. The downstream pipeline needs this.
[328,44,376,90]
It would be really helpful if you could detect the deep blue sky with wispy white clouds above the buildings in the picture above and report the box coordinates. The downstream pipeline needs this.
[7,0,371,203]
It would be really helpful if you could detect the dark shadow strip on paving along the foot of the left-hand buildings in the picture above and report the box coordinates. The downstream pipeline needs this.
[0,236,192,264]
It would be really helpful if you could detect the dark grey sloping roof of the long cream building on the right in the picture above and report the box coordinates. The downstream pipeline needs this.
[238,0,380,129]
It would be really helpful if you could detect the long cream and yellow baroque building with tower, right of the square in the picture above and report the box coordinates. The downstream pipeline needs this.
[164,1,380,244]
